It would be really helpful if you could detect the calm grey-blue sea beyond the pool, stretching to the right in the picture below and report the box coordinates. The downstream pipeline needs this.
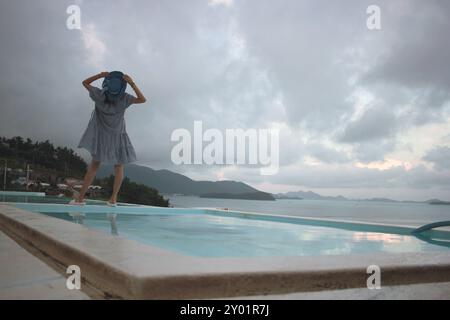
[168,195,450,226]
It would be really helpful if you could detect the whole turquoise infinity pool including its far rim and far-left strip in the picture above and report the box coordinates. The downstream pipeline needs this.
[0,193,450,257]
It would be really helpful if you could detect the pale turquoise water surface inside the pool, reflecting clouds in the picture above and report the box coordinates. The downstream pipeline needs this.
[43,212,450,257]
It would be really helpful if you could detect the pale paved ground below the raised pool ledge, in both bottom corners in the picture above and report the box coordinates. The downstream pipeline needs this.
[0,228,450,300]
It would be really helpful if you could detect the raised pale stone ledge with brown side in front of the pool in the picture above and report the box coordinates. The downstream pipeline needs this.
[0,205,450,299]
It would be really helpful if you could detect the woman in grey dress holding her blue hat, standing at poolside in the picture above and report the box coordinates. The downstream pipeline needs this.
[70,71,146,206]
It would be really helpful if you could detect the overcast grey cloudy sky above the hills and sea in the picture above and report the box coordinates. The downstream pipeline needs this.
[0,0,450,200]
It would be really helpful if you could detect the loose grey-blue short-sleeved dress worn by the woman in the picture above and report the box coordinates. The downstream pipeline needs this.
[78,86,136,164]
